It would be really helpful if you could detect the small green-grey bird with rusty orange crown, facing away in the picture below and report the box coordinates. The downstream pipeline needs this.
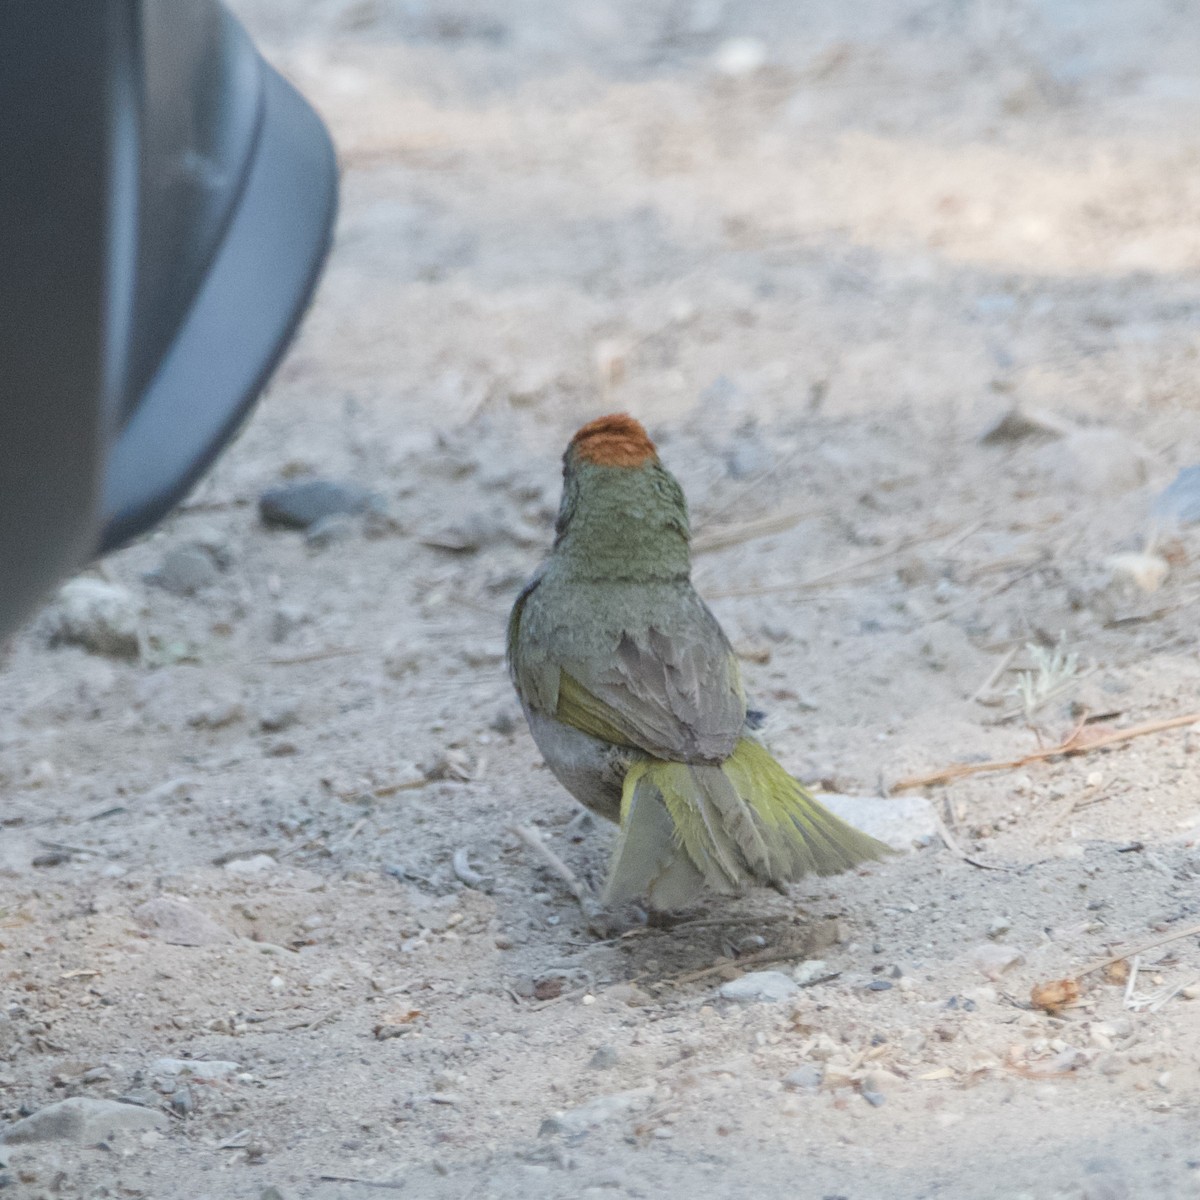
[506,413,888,911]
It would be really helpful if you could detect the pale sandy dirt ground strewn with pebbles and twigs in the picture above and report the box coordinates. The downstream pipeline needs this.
[0,0,1200,1200]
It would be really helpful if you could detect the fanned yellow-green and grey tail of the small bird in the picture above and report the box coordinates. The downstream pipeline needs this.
[605,738,888,908]
